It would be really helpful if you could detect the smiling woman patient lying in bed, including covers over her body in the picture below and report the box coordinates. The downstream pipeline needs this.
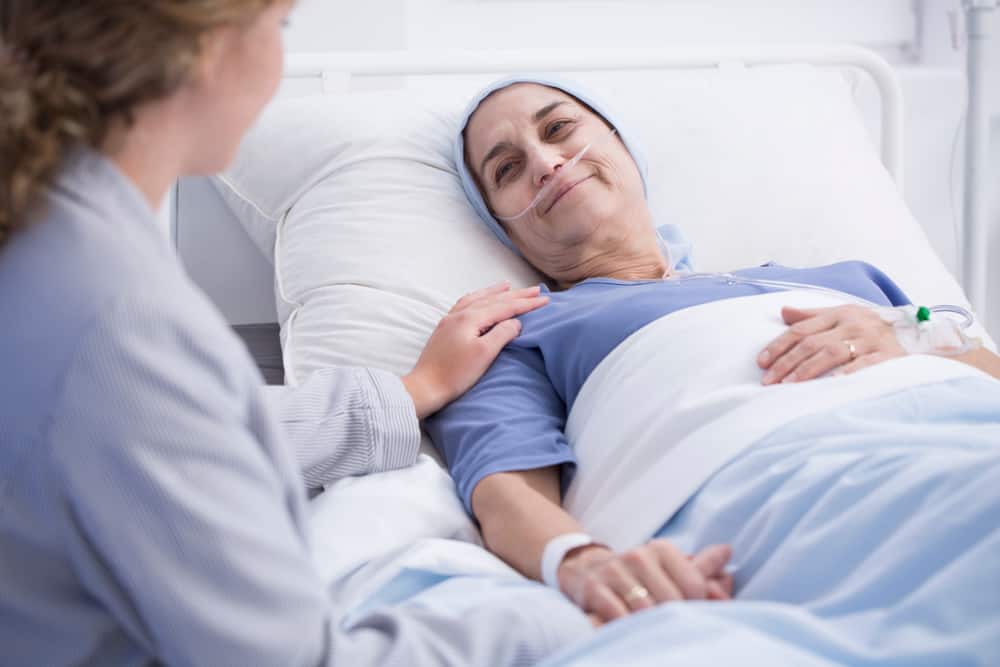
[427,79,1000,662]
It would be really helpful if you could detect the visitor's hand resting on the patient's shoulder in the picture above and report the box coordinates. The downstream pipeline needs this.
[403,282,549,419]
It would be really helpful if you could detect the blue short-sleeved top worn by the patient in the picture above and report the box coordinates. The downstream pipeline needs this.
[425,262,909,512]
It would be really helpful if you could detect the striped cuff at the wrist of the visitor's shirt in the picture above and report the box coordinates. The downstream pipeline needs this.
[366,369,420,472]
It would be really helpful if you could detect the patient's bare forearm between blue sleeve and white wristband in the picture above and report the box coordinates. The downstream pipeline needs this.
[472,466,581,580]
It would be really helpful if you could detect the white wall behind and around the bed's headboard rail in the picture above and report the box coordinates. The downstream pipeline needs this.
[274,0,1000,337]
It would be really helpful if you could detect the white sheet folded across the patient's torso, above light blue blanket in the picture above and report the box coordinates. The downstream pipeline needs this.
[564,291,980,549]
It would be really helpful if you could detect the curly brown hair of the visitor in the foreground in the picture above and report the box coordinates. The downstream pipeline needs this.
[0,0,277,248]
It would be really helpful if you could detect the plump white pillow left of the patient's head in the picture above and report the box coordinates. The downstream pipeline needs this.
[216,89,541,384]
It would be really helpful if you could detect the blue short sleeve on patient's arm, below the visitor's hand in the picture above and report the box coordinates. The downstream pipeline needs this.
[425,346,576,514]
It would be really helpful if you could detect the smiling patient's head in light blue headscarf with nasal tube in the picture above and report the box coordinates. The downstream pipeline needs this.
[465,83,649,277]
